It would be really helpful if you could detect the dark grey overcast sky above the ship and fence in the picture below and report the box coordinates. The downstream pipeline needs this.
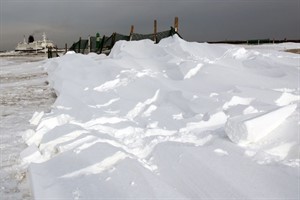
[0,0,300,50]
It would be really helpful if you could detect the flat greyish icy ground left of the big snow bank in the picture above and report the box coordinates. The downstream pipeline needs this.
[0,52,55,200]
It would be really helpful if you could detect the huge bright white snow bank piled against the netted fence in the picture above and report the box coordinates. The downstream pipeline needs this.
[15,36,300,199]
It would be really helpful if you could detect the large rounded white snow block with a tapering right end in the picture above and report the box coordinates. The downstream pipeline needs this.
[225,104,297,144]
